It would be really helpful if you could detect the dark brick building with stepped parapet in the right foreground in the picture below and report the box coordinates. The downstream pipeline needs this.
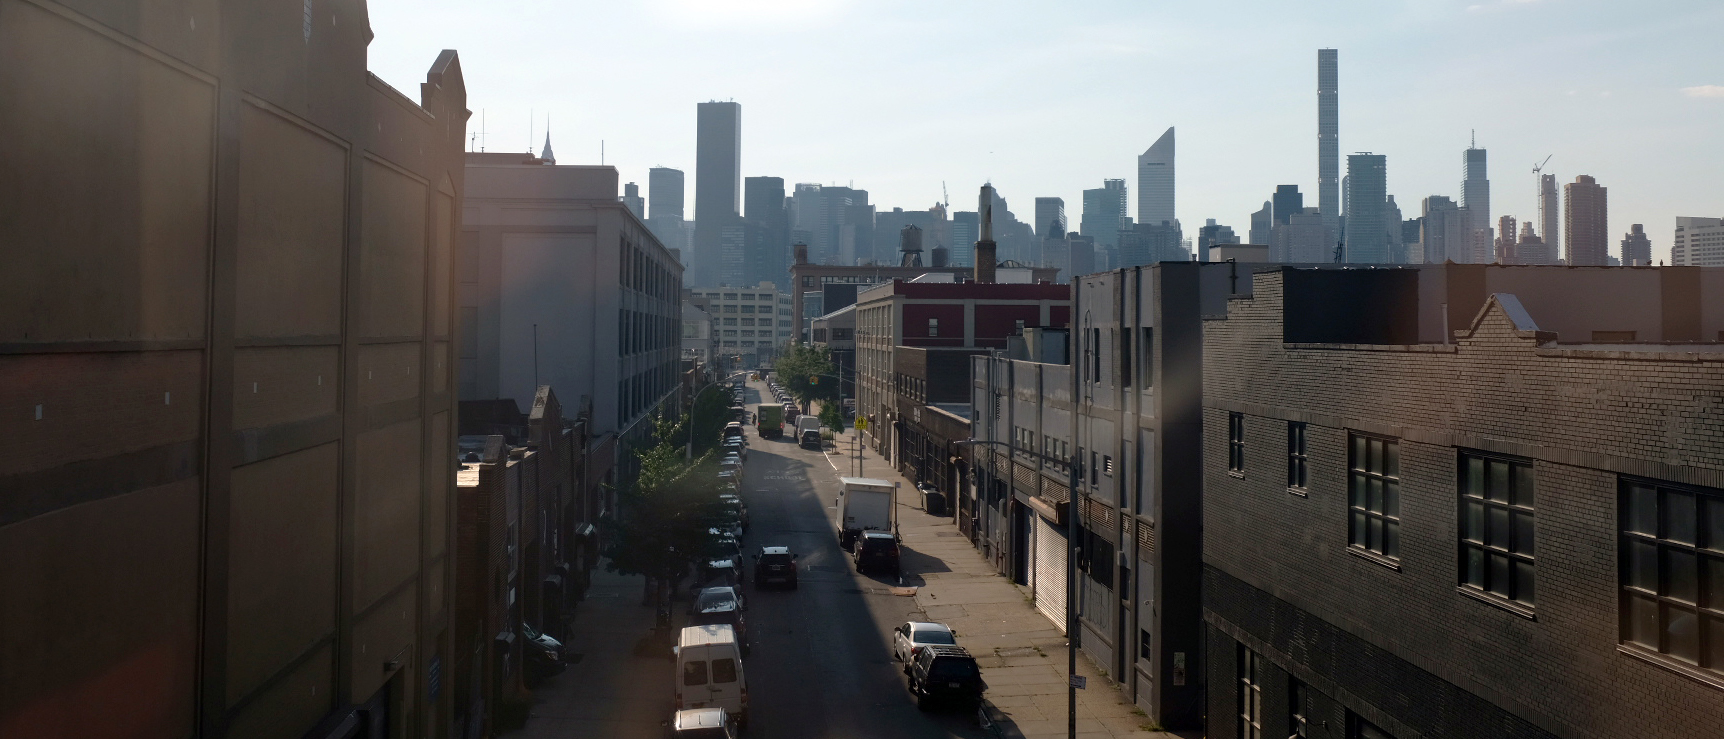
[1203,267,1724,739]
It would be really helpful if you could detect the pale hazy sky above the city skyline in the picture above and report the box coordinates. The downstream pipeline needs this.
[371,0,1724,258]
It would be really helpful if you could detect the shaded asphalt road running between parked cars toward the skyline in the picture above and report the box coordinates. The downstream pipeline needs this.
[720,382,986,739]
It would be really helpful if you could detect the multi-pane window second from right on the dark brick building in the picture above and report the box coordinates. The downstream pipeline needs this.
[1460,453,1533,605]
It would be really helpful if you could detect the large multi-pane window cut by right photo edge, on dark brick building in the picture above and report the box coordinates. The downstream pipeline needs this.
[1621,479,1724,674]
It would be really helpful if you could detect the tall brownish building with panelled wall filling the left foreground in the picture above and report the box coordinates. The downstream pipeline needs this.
[0,0,469,739]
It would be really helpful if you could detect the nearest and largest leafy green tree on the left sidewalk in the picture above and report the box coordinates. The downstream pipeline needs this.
[605,415,721,582]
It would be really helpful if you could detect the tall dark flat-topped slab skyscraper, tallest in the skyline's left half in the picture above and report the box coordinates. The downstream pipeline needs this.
[684,102,743,284]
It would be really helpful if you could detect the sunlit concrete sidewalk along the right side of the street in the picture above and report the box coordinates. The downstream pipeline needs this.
[813,429,1179,739]
